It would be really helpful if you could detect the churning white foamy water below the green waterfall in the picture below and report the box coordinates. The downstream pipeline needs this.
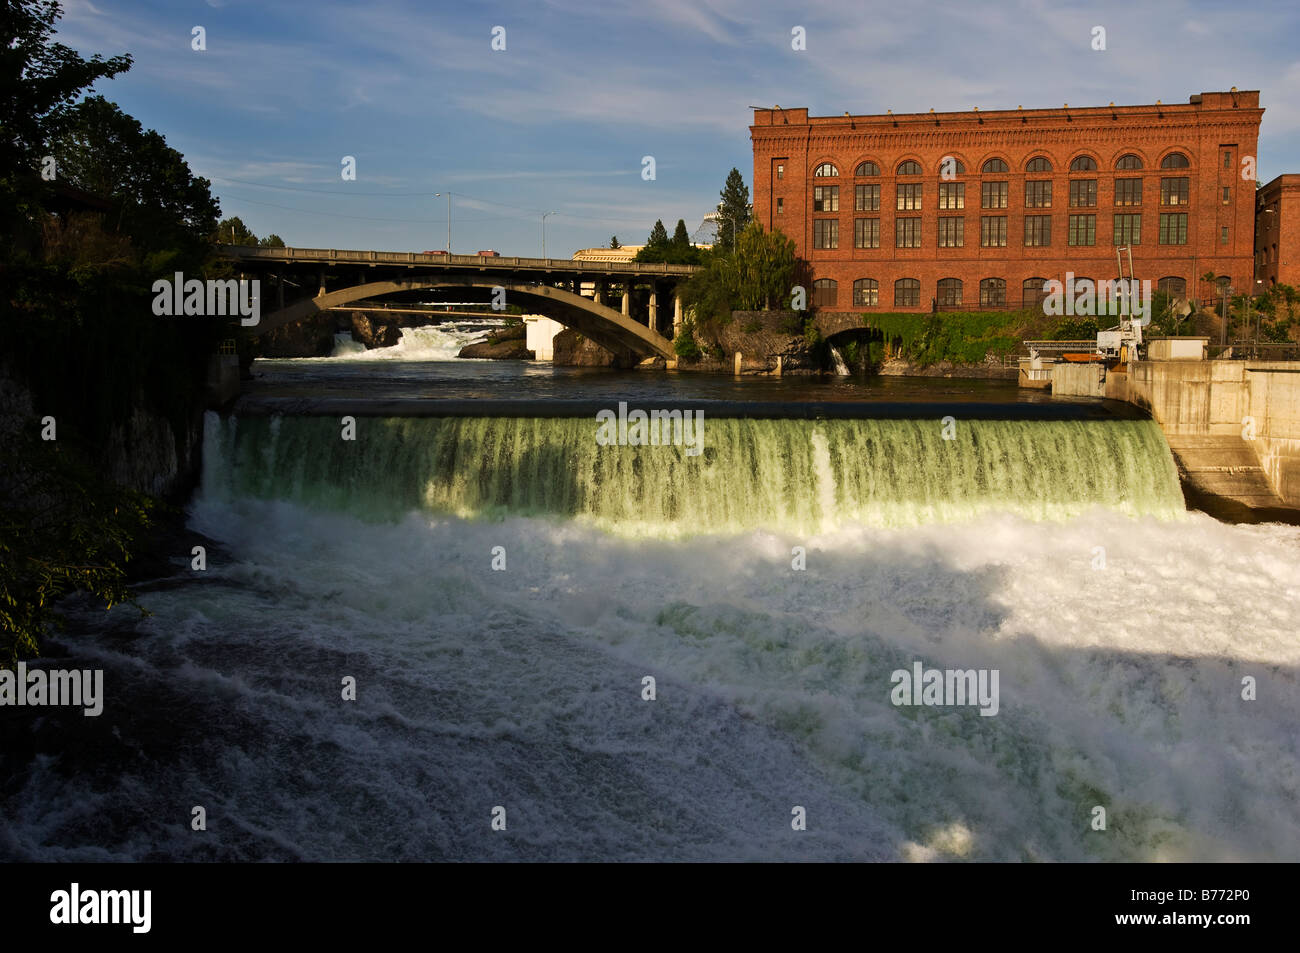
[0,499,1300,861]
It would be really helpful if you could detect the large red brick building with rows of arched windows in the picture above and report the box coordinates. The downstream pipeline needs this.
[750,88,1263,311]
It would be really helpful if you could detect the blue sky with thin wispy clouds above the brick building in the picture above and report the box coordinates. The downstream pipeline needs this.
[56,0,1300,257]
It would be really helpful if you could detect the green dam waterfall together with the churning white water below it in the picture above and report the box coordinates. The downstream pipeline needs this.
[0,415,1300,861]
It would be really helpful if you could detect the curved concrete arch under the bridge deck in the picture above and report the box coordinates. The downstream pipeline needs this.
[257,274,675,359]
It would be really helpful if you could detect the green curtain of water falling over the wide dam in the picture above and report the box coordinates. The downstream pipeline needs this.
[204,415,1184,536]
